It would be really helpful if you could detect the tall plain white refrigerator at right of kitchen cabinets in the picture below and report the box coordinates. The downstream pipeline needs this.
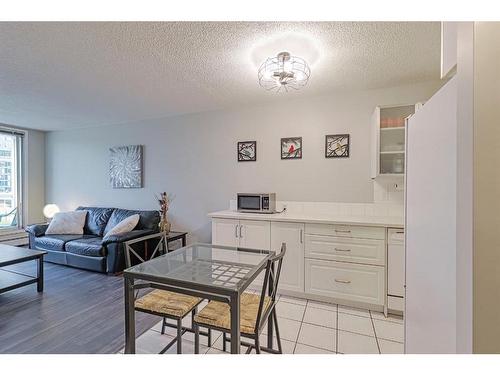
[405,78,457,353]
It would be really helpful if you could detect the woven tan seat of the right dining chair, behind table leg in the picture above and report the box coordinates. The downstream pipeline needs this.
[194,293,272,334]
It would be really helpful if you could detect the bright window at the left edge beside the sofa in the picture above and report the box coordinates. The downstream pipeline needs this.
[0,132,24,230]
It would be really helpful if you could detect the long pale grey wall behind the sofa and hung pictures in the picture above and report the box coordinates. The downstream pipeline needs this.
[46,82,440,241]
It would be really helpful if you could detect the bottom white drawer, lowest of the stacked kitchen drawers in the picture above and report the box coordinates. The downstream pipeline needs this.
[305,259,385,305]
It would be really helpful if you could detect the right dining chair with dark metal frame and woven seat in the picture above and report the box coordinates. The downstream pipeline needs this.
[193,243,286,354]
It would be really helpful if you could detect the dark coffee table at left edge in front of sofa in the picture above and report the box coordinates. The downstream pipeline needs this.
[0,245,47,293]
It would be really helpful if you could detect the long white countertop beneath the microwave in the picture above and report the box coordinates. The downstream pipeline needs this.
[208,210,404,228]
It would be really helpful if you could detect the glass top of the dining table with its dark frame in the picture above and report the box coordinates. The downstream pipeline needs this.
[124,243,274,291]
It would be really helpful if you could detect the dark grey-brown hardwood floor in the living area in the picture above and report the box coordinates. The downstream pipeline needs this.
[0,262,160,354]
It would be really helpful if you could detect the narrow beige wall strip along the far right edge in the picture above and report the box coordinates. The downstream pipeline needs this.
[473,22,500,354]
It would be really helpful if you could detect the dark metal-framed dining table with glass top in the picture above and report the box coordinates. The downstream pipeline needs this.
[123,243,275,354]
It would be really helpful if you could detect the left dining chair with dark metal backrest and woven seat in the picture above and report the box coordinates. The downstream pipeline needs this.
[124,233,212,354]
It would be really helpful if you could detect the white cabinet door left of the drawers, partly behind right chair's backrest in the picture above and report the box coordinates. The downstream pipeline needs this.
[271,221,305,293]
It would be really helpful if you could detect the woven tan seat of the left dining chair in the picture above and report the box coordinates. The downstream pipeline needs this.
[135,289,201,318]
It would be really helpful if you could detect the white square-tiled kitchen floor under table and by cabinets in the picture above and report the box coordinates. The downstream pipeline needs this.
[120,296,403,354]
